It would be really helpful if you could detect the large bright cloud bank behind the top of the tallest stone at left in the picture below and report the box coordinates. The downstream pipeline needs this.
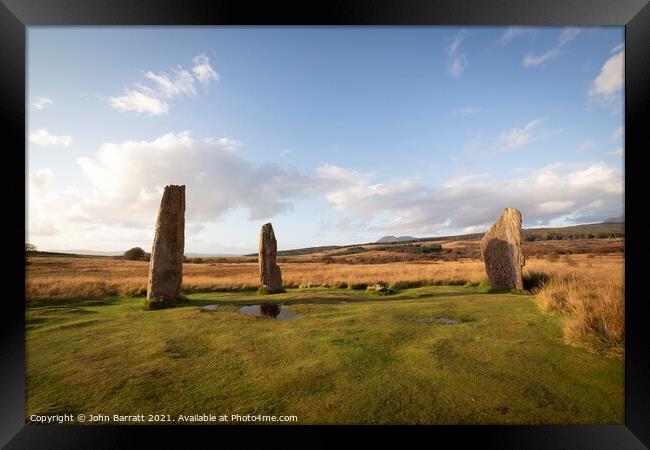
[26,132,370,250]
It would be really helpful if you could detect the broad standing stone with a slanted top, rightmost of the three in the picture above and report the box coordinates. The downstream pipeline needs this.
[481,208,526,290]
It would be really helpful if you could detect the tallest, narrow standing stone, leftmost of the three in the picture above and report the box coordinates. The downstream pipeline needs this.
[147,185,185,308]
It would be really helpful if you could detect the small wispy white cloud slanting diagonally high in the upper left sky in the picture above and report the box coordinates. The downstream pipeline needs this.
[108,55,219,116]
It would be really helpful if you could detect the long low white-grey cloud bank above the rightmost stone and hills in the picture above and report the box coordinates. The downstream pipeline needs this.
[318,163,623,233]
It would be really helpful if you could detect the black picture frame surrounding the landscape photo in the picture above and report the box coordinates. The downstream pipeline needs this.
[0,0,650,450]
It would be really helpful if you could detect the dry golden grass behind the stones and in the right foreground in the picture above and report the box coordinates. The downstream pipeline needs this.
[26,254,625,355]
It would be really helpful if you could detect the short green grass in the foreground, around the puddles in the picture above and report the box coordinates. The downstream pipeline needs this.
[26,286,624,424]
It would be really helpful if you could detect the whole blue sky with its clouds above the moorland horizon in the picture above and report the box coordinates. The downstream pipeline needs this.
[26,26,625,254]
